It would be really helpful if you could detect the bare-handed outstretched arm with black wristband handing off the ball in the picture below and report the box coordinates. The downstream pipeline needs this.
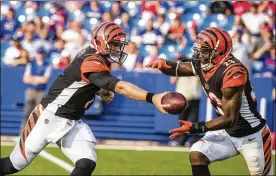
[85,71,168,114]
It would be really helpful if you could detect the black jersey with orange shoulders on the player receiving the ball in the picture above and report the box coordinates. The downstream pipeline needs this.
[192,55,266,137]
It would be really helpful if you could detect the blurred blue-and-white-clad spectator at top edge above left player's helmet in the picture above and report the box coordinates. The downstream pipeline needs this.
[84,0,104,19]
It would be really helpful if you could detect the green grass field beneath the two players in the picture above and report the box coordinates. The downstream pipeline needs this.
[1,146,275,175]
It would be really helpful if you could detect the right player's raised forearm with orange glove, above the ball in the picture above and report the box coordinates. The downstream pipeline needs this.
[146,59,195,76]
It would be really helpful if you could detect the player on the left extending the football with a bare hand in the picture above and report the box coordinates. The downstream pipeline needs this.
[0,22,167,176]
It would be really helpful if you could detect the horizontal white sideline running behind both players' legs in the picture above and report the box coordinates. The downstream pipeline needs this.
[1,142,275,155]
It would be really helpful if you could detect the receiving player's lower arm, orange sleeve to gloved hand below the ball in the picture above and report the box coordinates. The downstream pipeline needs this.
[170,68,247,139]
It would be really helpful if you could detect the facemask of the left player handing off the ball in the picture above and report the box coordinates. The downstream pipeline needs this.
[106,40,128,65]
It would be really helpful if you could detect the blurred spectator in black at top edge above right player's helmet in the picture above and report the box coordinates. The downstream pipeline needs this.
[209,1,234,15]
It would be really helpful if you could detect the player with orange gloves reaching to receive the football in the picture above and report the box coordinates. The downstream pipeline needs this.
[146,27,273,176]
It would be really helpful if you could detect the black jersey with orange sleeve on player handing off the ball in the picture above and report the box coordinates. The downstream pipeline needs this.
[41,47,110,120]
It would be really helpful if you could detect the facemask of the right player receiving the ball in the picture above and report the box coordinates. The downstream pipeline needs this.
[192,43,217,72]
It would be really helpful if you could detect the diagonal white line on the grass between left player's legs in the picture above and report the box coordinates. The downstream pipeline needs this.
[39,150,74,173]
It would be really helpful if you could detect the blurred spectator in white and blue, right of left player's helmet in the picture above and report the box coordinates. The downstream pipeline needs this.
[139,19,164,47]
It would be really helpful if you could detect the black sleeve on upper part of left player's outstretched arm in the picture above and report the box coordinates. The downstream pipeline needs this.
[85,71,120,92]
